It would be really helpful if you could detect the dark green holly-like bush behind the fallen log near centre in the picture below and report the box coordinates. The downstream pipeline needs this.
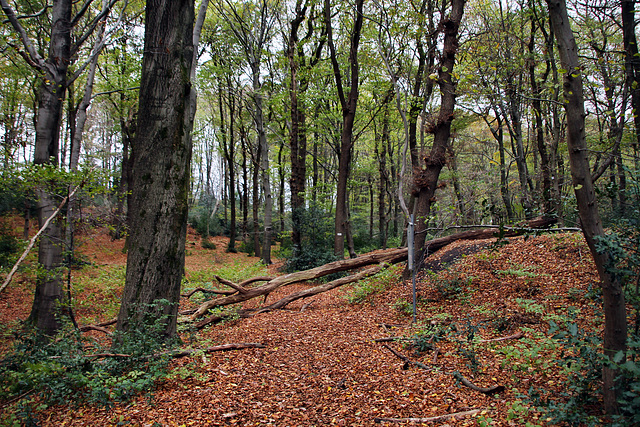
[281,205,337,272]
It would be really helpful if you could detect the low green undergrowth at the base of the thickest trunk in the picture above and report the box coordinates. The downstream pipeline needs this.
[0,303,176,423]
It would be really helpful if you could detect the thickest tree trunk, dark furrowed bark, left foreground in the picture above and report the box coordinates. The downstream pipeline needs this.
[117,0,194,337]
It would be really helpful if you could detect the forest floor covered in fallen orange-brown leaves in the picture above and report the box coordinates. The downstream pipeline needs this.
[0,222,601,427]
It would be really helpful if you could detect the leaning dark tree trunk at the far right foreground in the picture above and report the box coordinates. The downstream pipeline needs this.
[547,0,627,414]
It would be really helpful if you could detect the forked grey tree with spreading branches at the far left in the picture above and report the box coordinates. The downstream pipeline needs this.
[0,0,116,336]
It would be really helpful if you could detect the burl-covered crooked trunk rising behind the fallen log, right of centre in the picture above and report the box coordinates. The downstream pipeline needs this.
[412,0,465,274]
